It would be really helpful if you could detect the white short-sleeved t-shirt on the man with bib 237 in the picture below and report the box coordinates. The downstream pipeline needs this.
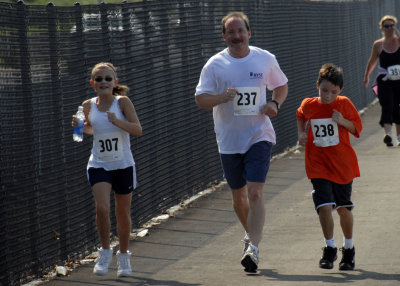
[195,46,288,154]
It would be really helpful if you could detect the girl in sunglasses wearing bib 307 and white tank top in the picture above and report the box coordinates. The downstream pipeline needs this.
[72,62,142,277]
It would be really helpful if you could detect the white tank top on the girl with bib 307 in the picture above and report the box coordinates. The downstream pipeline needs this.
[87,96,135,171]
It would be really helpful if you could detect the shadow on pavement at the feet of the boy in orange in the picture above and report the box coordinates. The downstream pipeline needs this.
[253,269,400,284]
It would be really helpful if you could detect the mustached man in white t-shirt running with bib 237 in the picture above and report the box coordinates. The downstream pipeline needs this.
[195,12,288,272]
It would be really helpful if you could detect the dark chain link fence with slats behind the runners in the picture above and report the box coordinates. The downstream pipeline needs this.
[0,0,400,285]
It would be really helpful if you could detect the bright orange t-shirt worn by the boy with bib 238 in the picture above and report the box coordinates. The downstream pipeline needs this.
[297,96,362,184]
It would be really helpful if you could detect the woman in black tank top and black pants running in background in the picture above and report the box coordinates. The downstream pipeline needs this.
[364,15,400,147]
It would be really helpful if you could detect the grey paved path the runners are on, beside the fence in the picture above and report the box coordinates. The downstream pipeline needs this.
[45,104,400,286]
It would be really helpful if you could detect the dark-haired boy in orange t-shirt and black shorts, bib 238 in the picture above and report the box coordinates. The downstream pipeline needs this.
[297,64,362,270]
